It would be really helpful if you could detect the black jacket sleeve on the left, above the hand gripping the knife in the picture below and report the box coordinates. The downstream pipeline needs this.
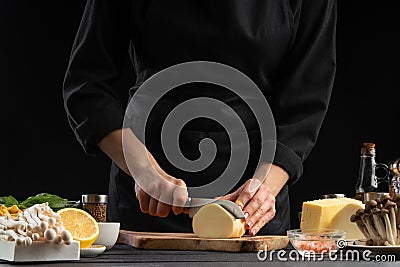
[63,0,130,154]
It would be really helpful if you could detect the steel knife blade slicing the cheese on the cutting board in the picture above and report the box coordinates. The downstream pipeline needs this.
[185,197,245,219]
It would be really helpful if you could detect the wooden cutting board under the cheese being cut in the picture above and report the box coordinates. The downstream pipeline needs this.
[118,230,289,252]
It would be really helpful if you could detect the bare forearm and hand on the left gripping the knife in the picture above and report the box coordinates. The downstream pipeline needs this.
[98,128,188,217]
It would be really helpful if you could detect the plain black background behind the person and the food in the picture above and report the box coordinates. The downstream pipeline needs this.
[0,0,400,226]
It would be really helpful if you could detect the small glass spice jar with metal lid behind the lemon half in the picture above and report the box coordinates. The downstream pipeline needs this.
[82,194,108,222]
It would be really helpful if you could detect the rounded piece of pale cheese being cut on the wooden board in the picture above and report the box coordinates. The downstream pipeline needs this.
[192,203,246,238]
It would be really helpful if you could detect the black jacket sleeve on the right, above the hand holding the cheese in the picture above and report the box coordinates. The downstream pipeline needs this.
[271,0,336,184]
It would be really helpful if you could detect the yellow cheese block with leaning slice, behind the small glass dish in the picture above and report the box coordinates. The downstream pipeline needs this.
[300,198,364,239]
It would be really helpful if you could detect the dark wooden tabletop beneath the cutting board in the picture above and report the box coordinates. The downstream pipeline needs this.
[0,245,400,267]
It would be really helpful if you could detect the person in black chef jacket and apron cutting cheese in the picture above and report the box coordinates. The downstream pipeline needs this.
[63,0,336,235]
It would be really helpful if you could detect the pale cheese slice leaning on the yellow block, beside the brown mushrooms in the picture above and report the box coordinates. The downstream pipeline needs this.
[330,203,364,239]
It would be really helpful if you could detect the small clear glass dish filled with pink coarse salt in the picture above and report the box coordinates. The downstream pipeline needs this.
[287,228,346,256]
